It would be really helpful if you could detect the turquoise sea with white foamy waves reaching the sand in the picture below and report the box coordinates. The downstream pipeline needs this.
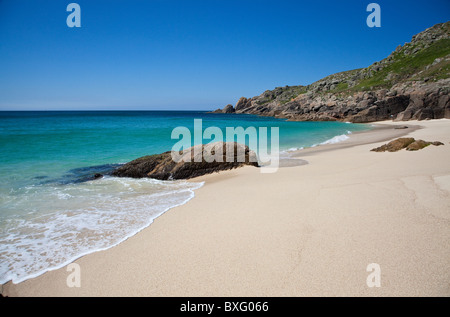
[0,111,368,283]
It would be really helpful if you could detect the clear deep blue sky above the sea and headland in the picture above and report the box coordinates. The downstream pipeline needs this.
[0,0,450,110]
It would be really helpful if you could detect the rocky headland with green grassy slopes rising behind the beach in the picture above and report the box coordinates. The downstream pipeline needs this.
[215,22,450,123]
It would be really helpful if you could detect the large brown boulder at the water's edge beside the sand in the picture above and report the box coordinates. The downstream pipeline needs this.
[112,142,258,180]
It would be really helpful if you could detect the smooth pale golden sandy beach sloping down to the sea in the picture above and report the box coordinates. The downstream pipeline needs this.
[0,119,450,297]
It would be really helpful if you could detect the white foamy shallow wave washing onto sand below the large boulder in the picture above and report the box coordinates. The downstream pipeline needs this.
[0,177,203,283]
